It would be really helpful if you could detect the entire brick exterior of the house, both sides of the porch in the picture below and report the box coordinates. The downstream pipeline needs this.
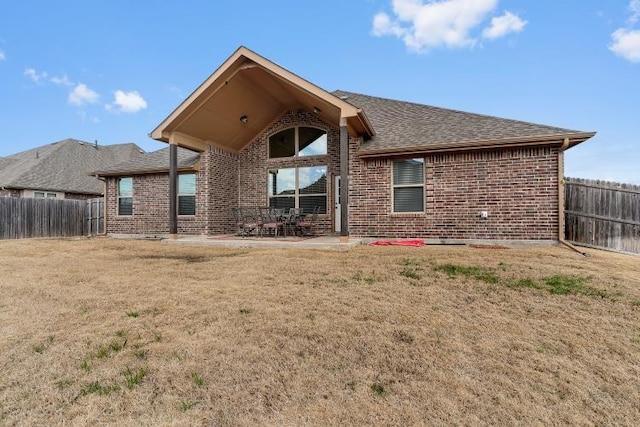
[106,110,559,240]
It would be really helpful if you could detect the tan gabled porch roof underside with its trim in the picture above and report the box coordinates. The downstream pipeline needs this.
[151,48,373,152]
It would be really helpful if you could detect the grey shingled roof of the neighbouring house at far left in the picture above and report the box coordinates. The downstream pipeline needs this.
[0,139,144,195]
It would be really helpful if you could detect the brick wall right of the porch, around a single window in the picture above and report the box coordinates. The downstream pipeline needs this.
[349,139,559,240]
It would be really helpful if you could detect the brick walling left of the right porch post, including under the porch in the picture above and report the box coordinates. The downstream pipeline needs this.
[106,110,340,235]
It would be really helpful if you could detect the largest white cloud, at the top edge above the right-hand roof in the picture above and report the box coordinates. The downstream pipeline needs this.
[372,0,526,52]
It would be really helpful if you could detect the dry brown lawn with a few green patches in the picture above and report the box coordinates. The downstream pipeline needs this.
[0,239,640,425]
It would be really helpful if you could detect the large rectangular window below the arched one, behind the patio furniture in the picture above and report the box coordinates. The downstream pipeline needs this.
[268,166,327,214]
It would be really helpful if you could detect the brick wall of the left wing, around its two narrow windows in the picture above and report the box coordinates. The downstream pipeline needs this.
[105,172,207,235]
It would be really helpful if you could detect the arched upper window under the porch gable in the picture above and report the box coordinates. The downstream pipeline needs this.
[269,126,327,159]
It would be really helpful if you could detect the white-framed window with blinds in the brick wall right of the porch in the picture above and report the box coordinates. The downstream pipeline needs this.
[393,159,424,212]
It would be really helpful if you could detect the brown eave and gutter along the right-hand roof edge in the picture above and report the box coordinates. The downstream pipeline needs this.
[358,132,596,158]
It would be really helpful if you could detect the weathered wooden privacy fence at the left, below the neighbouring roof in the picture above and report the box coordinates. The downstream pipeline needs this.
[0,197,104,239]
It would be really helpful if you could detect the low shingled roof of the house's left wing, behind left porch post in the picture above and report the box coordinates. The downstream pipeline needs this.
[94,147,200,176]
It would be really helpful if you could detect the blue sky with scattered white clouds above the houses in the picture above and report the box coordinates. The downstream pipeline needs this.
[0,0,640,184]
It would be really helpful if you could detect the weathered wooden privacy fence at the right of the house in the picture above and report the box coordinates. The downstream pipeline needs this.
[565,178,640,254]
